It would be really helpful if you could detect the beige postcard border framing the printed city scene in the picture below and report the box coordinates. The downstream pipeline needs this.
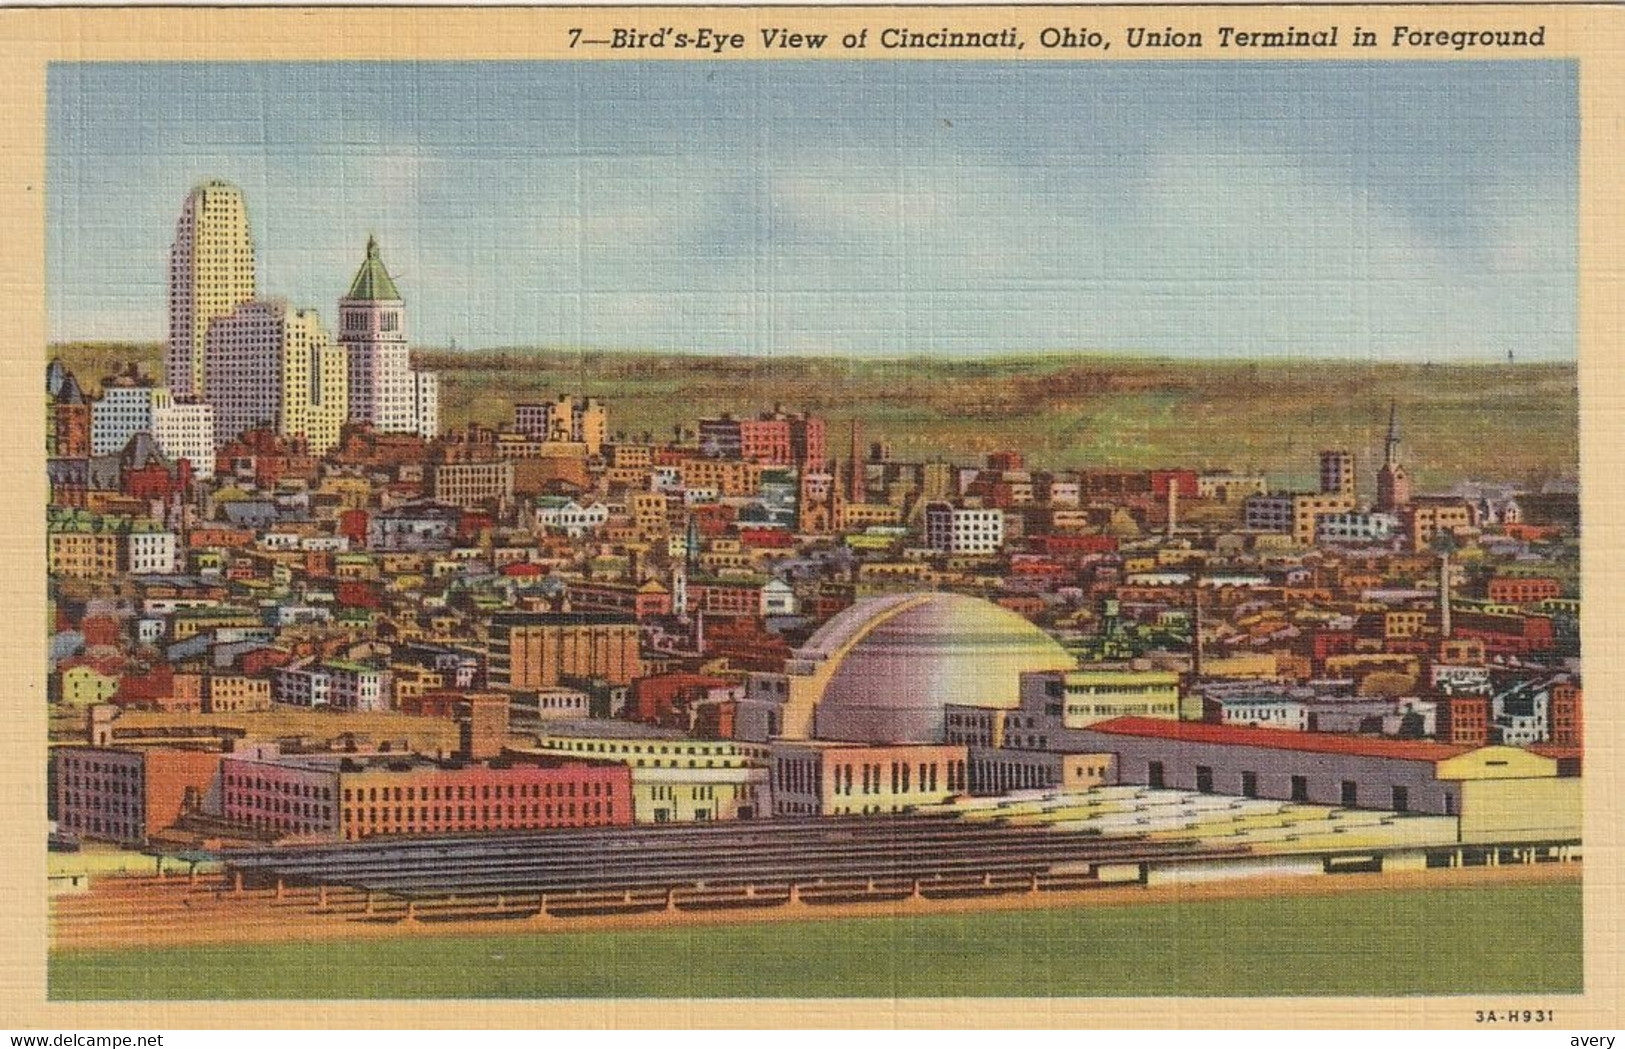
[0,5,1625,1030]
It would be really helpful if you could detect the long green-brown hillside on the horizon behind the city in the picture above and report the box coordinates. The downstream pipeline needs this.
[54,344,1580,486]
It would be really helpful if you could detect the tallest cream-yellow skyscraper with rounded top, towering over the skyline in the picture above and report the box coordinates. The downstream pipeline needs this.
[164,182,254,401]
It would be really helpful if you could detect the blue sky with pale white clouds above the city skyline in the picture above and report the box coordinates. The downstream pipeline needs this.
[47,62,1578,360]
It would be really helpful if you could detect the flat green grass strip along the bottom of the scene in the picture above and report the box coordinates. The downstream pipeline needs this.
[50,883,1583,999]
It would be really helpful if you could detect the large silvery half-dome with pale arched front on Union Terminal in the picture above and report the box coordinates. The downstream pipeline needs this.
[796,593,1074,742]
